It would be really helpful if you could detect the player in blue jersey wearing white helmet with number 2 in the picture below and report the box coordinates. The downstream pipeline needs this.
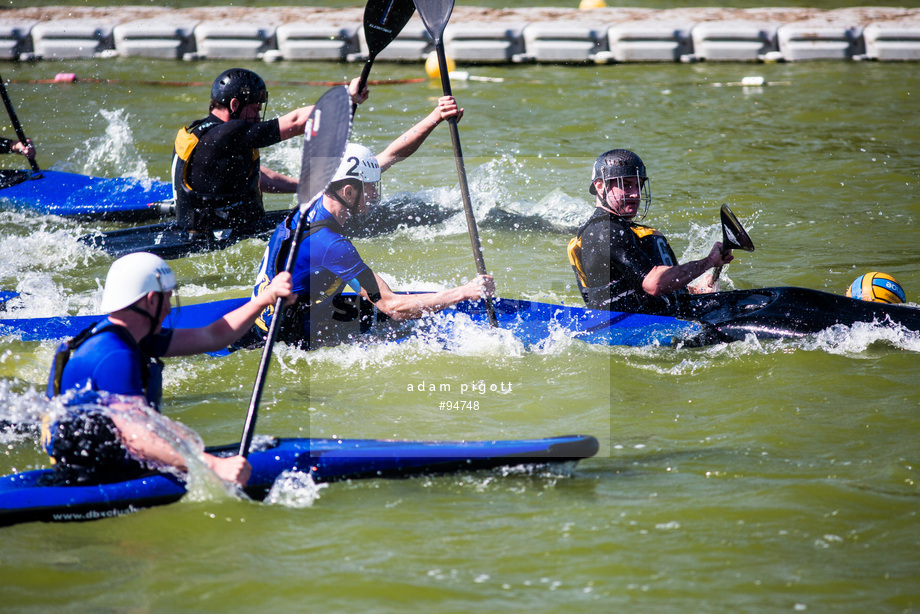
[241,140,495,349]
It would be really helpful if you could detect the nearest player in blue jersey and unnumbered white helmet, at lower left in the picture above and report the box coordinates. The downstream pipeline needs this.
[42,252,293,486]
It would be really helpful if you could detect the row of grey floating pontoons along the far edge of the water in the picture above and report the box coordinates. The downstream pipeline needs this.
[0,7,920,64]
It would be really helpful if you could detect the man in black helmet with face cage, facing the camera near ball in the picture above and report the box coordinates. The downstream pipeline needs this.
[568,149,733,314]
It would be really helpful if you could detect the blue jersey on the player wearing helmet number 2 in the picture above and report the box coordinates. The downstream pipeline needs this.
[253,197,378,347]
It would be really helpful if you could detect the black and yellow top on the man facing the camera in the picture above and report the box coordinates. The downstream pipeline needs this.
[576,208,686,314]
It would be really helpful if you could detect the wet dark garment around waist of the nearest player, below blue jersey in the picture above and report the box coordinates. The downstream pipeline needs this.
[49,412,152,486]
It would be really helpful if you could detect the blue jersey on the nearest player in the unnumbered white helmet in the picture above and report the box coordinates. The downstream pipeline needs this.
[47,320,172,407]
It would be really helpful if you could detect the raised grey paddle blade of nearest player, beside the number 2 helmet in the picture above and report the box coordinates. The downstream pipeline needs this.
[297,85,351,208]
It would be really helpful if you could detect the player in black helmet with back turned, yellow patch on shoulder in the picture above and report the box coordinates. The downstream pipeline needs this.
[172,68,368,232]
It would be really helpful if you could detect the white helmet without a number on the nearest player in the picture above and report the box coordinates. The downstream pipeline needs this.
[100,252,176,313]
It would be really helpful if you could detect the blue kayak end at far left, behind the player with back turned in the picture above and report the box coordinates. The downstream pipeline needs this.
[0,170,172,221]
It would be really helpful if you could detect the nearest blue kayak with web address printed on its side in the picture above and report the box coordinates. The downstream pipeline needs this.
[0,435,598,526]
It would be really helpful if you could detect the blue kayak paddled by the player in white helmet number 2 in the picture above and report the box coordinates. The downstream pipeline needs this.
[0,294,700,354]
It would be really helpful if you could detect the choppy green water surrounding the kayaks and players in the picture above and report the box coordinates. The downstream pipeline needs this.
[0,59,920,612]
